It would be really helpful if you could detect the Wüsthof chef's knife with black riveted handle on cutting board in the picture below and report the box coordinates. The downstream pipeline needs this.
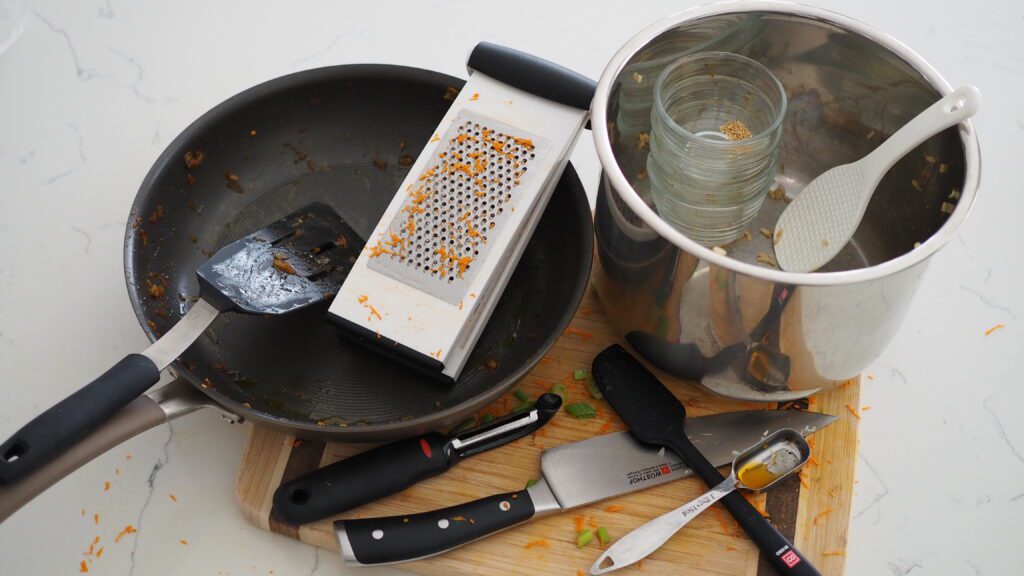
[334,410,836,566]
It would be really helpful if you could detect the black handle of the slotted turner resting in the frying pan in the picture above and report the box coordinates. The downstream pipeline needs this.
[0,354,160,485]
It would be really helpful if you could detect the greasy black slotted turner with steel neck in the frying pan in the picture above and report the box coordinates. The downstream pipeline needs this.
[0,204,362,484]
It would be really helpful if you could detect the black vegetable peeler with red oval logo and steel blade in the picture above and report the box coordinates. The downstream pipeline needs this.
[273,394,562,526]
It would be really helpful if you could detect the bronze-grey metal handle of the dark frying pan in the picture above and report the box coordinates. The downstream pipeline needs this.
[0,378,212,523]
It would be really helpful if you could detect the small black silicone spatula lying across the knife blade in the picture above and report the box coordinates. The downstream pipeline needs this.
[593,344,819,576]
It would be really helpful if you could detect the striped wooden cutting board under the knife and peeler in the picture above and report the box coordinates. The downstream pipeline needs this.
[237,293,860,576]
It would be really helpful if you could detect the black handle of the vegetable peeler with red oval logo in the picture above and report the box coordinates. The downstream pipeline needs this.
[273,433,452,526]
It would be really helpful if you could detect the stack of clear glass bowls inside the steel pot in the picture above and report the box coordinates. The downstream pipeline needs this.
[647,52,785,246]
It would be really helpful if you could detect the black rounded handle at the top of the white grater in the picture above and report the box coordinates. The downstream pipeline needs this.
[466,42,597,110]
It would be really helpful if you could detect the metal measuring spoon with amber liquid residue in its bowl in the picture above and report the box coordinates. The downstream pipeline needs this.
[590,428,811,576]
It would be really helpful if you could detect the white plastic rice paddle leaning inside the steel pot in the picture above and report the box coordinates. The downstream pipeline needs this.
[774,86,981,272]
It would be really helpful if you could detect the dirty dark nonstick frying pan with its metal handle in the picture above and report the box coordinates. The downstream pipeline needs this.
[0,65,593,520]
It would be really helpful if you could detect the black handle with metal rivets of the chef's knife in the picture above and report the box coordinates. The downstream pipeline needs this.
[334,490,535,566]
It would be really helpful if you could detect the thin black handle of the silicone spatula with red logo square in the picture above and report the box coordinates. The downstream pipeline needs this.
[666,438,821,576]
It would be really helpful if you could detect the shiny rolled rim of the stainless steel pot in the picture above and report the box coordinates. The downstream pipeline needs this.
[591,0,981,286]
